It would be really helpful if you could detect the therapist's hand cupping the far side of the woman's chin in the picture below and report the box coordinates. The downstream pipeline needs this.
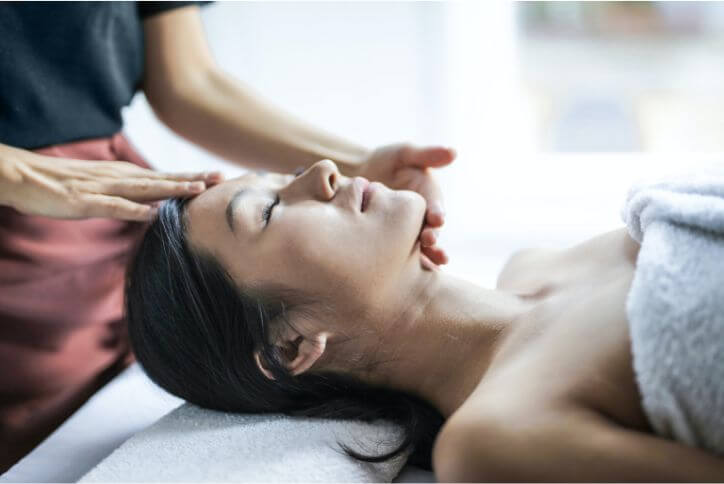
[359,144,455,264]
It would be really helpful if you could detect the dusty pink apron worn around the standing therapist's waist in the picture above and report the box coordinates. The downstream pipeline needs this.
[0,133,149,473]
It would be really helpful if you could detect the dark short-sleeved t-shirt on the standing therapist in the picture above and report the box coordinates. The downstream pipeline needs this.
[0,2,207,149]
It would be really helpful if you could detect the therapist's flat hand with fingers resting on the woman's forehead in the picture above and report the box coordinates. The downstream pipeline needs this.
[0,149,223,221]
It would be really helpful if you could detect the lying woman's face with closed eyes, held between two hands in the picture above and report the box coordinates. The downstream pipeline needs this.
[187,160,425,311]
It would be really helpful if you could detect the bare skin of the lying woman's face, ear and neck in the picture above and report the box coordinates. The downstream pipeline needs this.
[187,161,516,404]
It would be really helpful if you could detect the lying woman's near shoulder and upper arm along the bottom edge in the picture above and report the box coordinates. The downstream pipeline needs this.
[433,396,724,482]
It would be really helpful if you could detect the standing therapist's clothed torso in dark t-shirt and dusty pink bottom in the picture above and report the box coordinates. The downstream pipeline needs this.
[0,2,204,473]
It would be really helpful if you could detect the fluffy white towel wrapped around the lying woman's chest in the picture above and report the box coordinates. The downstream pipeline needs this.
[621,164,724,454]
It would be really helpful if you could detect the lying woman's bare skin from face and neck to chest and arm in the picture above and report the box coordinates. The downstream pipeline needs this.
[187,161,724,482]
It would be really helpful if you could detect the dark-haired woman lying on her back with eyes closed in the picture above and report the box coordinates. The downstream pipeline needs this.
[127,160,724,482]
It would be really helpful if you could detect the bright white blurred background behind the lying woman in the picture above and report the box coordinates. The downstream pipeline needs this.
[124,0,724,287]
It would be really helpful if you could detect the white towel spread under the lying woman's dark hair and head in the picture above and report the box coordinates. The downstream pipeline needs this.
[79,403,408,482]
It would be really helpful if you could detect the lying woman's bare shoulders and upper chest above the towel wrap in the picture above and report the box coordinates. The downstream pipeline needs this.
[433,228,724,482]
